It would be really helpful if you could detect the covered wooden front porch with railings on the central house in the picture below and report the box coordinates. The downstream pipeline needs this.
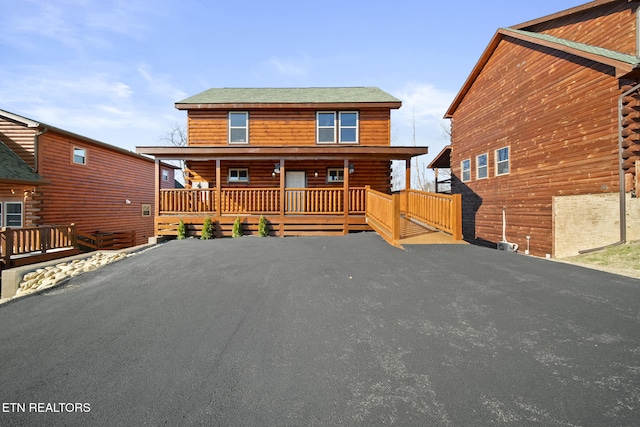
[137,146,427,236]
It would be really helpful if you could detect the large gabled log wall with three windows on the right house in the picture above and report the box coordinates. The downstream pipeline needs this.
[451,38,622,256]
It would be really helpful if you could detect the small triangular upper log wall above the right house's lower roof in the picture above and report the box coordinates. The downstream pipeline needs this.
[523,2,638,55]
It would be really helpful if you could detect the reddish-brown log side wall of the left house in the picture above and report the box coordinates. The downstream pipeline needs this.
[39,131,155,244]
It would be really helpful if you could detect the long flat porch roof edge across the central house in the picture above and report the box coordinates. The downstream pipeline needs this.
[136,145,429,160]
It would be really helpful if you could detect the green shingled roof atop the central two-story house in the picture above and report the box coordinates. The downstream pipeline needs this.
[177,87,400,104]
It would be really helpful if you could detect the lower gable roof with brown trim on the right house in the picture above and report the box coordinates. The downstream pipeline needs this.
[444,25,640,118]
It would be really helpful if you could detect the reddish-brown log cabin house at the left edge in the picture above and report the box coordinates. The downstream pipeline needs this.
[0,110,176,244]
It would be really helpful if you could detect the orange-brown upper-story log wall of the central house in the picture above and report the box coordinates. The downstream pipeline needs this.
[188,109,390,147]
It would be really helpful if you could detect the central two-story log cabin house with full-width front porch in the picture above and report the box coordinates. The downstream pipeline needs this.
[137,87,427,236]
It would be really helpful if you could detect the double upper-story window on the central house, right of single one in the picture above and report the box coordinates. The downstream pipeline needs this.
[316,111,359,144]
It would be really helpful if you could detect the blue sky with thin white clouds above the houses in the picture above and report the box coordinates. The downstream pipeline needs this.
[0,0,585,175]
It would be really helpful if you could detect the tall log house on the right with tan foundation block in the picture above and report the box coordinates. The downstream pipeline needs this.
[442,0,640,257]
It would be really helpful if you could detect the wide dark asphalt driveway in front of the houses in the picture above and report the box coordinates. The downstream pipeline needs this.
[0,233,640,426]
